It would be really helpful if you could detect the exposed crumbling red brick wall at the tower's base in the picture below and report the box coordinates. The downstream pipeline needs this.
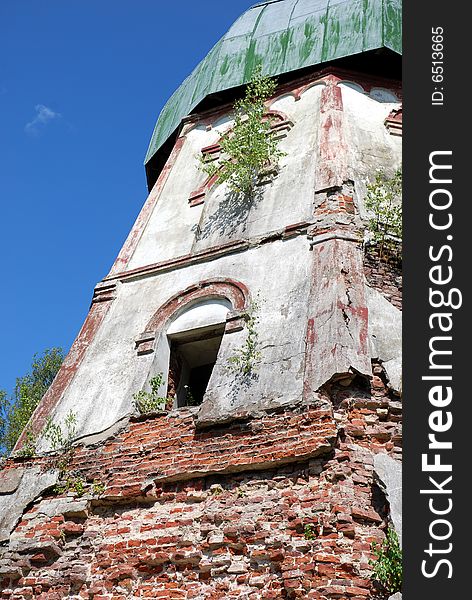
[0,366,401,600]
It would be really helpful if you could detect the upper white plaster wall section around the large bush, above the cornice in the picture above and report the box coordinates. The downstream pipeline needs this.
[128,85,321,269]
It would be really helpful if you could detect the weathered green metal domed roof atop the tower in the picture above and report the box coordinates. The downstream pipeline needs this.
[145,0,402,164]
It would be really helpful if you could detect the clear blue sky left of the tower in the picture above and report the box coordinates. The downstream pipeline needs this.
[0,0,255,391]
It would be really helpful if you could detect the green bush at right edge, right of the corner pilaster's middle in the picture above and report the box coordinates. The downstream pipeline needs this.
[365,168,403,261]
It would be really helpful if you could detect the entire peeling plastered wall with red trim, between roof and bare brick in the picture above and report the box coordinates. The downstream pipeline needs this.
[18,69,401,446]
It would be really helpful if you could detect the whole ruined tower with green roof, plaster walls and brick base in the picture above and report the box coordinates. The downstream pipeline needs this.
[0,0,402,600]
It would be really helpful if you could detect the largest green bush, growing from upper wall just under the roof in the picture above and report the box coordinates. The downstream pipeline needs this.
[201,67,284,196]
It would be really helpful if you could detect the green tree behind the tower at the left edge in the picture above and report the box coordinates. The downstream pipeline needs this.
[0,348,64,456]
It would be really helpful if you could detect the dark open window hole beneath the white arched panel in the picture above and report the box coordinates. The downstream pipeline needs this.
[167,324,225,407]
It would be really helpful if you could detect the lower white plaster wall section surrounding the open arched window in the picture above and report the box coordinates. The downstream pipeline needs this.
[43,237,310,436]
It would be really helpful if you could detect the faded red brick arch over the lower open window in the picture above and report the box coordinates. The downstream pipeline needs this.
[135,278,249,355]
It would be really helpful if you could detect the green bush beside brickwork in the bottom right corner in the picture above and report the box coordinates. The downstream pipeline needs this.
[369,527,403,594]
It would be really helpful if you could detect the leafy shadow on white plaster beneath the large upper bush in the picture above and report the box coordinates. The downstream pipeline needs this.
[195,186,264,242]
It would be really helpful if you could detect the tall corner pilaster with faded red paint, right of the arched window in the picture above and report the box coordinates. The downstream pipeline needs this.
[304,75,371,394]
